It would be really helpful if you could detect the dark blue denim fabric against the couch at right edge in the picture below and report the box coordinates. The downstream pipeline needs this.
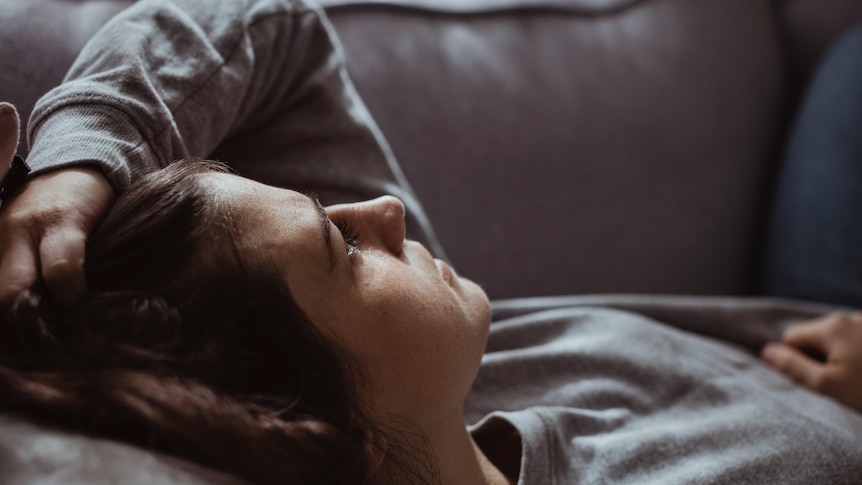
[761,28,862,308]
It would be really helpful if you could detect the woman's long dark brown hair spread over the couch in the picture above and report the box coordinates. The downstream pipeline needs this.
[0,161,434,484]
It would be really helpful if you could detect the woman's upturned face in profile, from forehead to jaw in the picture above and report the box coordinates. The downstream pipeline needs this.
[204,174,490,426]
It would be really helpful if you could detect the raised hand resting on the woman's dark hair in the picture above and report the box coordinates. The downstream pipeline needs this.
[0,167,114,304]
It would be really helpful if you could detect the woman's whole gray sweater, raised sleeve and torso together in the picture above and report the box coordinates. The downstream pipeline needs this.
[18,0,862,484]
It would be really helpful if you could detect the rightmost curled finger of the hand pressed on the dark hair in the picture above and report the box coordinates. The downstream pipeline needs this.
[39,226,87,303]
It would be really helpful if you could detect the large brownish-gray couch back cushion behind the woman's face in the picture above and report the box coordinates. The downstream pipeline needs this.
[331,0,785,297]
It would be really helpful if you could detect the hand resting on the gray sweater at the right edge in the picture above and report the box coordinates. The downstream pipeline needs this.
[761,313,862,413]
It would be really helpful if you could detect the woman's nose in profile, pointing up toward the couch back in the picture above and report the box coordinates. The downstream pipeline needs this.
[326,195,407,256]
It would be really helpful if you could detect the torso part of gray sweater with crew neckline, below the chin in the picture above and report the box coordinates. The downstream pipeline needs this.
[465,296,862,485]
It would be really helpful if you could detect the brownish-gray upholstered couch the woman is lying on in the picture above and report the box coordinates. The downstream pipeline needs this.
[0,0,862,483]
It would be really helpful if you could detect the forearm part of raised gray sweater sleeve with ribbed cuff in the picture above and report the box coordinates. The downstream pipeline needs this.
[28,0,320,190]
